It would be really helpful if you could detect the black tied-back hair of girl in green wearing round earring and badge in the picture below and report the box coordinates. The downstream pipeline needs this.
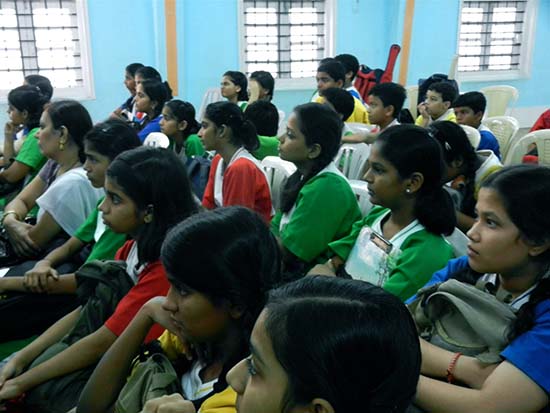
[375,125,456,235]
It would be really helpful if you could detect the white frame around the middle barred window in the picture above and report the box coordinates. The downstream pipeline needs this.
[238,0,337,90]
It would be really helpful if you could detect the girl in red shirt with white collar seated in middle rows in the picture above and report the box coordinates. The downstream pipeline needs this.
[199,102,273,222]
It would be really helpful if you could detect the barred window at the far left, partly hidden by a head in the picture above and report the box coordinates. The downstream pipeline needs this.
[0,0,93,98]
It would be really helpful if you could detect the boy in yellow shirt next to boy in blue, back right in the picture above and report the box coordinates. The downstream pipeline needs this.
[415,82,458,128]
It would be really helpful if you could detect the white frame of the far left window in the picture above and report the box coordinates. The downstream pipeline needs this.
[0,0,95,103]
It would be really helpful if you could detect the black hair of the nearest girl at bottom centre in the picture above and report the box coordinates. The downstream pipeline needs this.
[265,276,421,413]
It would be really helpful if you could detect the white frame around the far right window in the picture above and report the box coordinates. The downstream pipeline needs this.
[456,0,538,82]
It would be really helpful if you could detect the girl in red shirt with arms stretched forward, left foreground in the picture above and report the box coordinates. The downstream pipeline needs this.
[0,147,197,412]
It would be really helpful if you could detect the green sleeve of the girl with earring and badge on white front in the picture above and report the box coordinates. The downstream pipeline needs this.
[383,230,453,301]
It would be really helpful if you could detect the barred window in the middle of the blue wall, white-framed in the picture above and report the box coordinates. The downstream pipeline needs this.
[239,0,334,88]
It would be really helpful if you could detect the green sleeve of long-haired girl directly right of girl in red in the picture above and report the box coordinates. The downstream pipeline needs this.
[281,173,361,262]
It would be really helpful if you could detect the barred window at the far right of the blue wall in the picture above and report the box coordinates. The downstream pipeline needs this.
[458,0,536,79]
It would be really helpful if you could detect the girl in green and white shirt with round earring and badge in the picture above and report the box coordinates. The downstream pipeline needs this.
[311,125,456,300]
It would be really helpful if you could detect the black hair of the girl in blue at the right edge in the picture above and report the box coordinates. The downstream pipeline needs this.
[481,165,550,340]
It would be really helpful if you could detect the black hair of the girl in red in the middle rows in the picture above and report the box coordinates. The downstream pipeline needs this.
[204,101,260,151]
